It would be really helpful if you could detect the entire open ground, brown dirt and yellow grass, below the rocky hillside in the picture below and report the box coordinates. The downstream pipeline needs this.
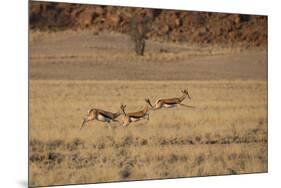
[29,31,267,186]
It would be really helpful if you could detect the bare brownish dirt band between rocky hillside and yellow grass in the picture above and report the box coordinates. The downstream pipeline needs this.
[29,31,267,80]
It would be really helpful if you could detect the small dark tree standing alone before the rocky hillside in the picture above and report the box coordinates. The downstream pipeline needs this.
[130,16,151,56]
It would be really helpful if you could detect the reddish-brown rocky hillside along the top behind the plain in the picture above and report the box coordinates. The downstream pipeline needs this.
[29,2,267,46]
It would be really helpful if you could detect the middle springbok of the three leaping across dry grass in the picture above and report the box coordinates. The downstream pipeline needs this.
[120,104,149,126]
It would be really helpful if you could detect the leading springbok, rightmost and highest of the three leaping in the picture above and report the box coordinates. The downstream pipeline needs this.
[145,89,194,110]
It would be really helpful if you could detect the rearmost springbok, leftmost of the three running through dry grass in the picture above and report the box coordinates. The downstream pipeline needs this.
[80,108,121,129]
